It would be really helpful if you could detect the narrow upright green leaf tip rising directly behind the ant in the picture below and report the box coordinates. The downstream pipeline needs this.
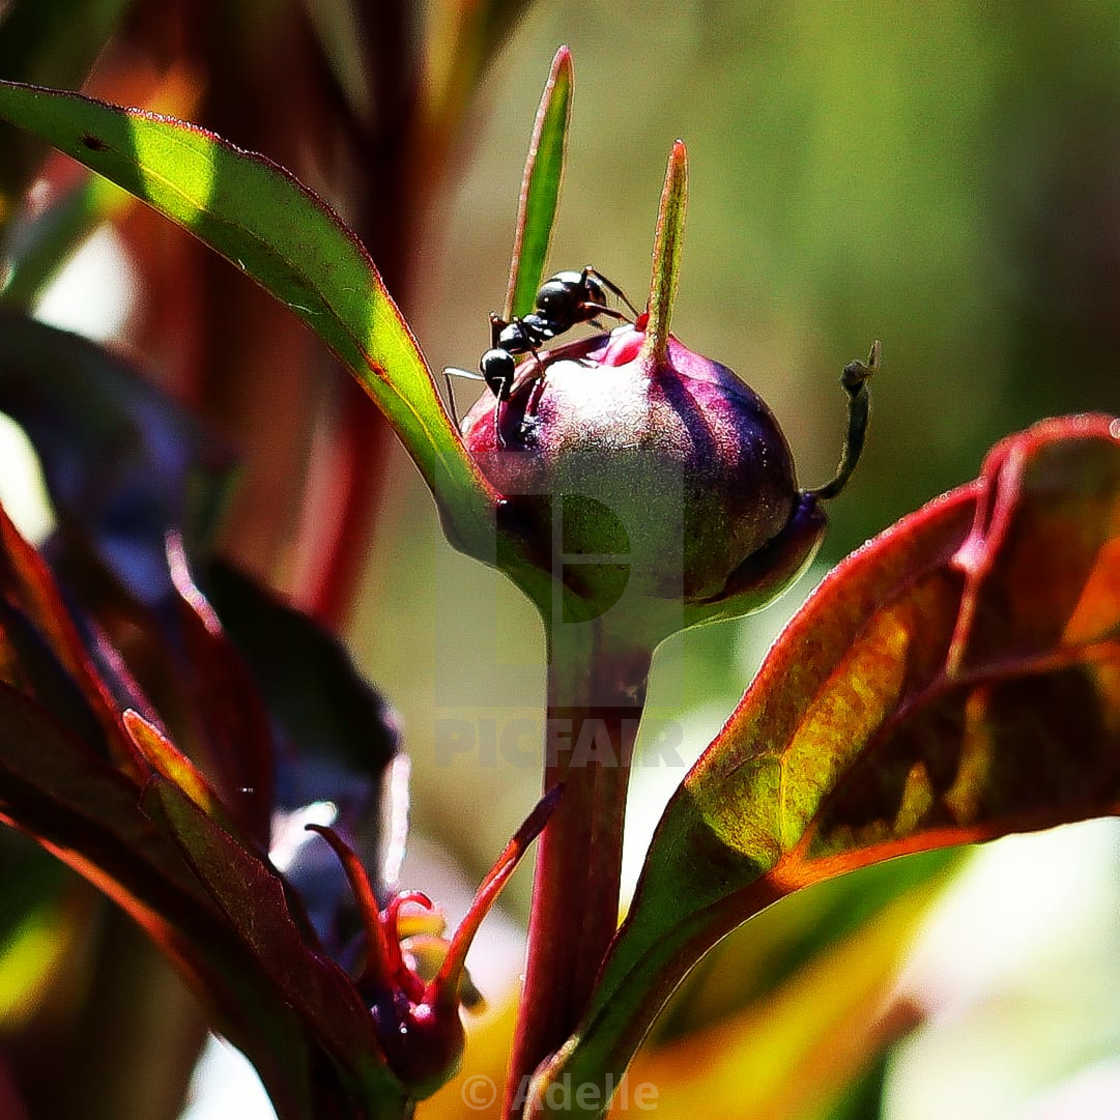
[503,47,572,319]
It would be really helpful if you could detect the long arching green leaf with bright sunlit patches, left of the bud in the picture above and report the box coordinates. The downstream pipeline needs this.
[0,82,496,556]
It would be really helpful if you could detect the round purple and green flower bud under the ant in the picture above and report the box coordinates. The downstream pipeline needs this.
[464,316,866,636]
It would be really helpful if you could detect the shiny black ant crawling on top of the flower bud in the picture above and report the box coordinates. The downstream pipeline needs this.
[444,265,641,447]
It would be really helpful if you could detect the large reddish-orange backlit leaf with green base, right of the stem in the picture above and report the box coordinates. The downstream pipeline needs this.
[531,416,1120,1116]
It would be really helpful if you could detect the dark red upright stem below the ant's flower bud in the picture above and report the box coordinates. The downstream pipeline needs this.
[504,622,651,1118]
